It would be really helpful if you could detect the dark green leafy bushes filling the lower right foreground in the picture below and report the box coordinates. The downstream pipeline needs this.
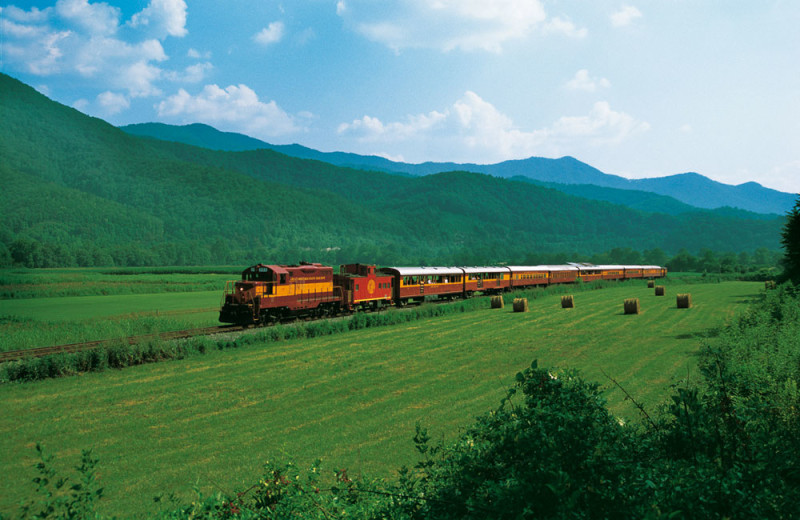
[7,284,800,519]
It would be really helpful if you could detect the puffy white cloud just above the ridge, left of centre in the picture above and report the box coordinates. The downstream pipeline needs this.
[156,85,305,138]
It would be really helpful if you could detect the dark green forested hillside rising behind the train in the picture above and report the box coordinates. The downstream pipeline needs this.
[0,75,783,266]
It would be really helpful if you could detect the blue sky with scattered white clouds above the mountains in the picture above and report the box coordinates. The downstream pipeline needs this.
[0,0,800,193]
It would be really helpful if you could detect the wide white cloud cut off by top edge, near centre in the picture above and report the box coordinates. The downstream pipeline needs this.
[336,0,586,52]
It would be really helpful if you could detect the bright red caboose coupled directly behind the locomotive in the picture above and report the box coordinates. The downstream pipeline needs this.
[333,264,393,312]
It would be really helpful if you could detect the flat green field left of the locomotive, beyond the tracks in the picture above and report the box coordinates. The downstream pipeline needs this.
[0,268,231,352]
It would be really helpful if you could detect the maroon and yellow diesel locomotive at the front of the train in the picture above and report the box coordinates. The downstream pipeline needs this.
[219,262,342,324]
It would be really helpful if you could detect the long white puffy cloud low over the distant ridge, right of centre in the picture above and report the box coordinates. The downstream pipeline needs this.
[338,91,649,161]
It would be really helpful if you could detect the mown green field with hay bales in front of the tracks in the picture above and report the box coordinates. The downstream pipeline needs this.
[0,282,763,516]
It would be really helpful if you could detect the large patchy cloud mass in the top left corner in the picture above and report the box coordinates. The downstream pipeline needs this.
[0,0,191,105]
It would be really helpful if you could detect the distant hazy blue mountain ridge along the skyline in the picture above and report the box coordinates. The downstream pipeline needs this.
[122,123,795,215]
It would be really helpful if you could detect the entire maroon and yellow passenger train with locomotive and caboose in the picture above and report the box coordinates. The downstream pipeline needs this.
[219,262,667,325]
